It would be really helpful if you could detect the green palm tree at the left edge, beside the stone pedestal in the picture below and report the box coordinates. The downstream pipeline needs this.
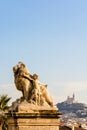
[0,95,11,130]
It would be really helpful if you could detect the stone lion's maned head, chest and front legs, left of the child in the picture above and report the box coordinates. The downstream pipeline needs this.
[13,62,33,101]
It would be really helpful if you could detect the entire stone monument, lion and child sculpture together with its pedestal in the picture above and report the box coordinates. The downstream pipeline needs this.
[7,62,61,130]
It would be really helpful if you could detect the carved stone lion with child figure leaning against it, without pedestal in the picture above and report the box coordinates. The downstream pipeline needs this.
[13,62,53,111]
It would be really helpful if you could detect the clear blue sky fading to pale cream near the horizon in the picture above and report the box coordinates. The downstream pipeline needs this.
[0,0,87,103]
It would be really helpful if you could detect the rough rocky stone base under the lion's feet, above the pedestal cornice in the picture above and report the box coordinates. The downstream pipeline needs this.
[9,101,58,113]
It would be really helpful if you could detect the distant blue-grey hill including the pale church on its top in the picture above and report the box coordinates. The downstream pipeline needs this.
[57,94,87,118]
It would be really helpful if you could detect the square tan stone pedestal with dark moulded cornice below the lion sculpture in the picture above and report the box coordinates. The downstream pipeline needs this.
[7,110,61,130]
